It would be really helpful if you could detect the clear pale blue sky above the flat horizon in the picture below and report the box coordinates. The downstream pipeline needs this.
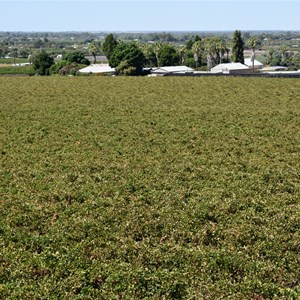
[0,0,300,32]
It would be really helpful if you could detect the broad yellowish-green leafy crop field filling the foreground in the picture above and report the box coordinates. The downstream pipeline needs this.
[0,77,300,300]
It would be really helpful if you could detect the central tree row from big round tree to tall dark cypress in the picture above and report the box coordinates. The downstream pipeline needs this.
[102,30,244,75]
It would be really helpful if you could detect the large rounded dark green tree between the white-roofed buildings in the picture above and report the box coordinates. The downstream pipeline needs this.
[109,42,146,75]
